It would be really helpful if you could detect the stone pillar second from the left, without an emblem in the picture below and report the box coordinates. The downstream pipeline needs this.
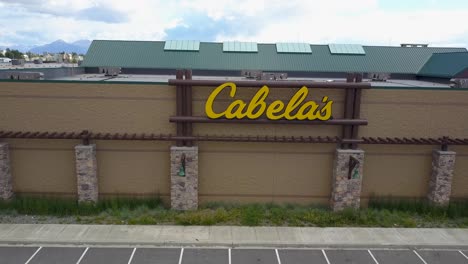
[75,144,99,202]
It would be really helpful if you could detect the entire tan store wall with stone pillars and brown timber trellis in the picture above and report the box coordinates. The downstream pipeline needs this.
[0,76,468,210]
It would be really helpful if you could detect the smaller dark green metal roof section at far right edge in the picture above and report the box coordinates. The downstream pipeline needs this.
[418,52,468,78]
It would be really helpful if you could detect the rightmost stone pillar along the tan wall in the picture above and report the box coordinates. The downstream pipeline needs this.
[427,150,456,205]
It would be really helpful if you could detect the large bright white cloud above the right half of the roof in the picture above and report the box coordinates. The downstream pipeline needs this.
[217,1,468,46]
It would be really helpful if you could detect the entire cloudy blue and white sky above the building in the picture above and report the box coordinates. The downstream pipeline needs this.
[0,0,468,47]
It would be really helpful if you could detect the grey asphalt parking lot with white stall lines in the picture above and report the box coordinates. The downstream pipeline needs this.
[0,246,468,264]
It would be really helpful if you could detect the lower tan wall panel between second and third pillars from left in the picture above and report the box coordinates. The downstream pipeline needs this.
[96,141,170,197]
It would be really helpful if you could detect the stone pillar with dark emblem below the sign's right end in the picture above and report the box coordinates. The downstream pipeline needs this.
[331,149,364,211]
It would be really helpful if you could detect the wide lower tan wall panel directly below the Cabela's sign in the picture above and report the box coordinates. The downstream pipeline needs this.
[199,143,334,203]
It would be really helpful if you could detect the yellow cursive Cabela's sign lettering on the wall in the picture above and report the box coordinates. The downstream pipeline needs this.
[205,82,333,121]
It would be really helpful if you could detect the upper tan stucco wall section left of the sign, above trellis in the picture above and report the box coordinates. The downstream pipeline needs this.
[0,82,175,133]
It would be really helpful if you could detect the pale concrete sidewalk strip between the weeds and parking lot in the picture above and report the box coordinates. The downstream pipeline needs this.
[0,224,468,249]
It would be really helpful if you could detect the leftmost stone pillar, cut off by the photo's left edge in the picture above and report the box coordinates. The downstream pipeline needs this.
[0,142,13,200]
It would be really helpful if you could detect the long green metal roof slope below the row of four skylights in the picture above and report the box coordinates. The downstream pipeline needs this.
[82,40,468,74]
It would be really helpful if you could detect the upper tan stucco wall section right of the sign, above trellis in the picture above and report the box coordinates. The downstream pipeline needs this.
[360,89,468,138]
